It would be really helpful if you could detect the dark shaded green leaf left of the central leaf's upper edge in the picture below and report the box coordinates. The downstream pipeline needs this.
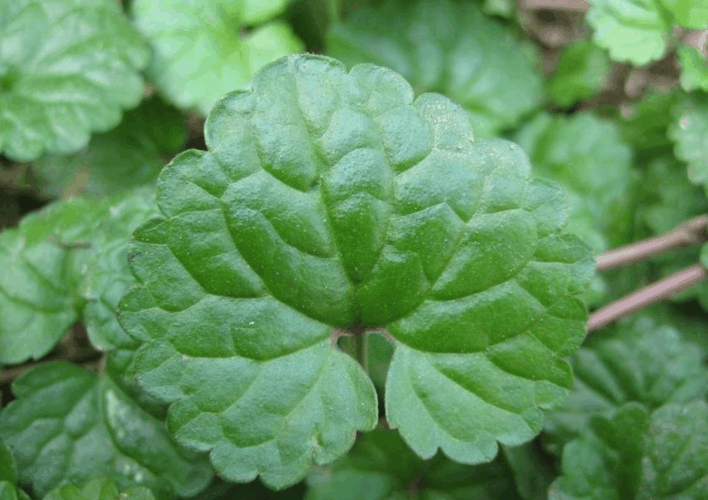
[32,97,187,197]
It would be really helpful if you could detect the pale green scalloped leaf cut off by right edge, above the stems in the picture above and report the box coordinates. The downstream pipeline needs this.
[668,93,708,192]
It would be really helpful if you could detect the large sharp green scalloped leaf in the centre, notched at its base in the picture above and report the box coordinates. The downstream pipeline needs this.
[119,56,594,487]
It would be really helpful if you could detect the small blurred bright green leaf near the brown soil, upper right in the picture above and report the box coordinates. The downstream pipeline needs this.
[547,42,610,107]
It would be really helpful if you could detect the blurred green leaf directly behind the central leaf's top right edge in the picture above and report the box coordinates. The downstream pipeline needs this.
[327,0,542,136]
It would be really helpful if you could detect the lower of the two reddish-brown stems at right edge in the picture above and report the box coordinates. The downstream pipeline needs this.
[587,264,708,333]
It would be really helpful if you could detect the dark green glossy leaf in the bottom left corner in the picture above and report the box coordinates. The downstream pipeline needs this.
[0,362,212,499]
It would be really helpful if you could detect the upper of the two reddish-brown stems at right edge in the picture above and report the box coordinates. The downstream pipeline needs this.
[597,215,708,272]
